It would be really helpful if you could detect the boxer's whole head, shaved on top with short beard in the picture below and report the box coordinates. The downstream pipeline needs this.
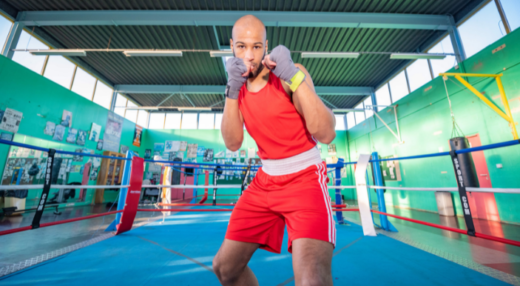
[230,15,267,77]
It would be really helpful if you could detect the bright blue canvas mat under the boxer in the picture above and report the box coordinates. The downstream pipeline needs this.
[0,209,508,286]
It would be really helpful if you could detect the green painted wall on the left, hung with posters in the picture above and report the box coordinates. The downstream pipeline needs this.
[0,53,145,207]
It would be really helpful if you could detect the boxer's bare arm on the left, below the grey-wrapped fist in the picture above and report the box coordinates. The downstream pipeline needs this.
[220,97,244,151]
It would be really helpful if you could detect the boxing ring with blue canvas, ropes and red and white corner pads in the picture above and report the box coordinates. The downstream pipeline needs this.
[0,140,520,285]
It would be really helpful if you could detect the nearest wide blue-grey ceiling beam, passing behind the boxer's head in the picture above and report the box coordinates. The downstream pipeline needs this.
[18,10,450,30]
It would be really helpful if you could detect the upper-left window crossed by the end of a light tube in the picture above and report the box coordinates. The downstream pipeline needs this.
[13,31,49,74]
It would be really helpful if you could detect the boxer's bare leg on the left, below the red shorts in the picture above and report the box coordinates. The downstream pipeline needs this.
[213,239,260,286]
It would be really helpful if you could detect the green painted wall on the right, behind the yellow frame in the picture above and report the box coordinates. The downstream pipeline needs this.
[347,26,520,223]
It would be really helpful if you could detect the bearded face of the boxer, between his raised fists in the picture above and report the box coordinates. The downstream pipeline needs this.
[231,27,267,78]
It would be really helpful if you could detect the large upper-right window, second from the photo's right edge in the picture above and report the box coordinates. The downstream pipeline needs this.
[459,1,505,58]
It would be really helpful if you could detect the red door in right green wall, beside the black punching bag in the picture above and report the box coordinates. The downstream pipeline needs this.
[467,134,500,221]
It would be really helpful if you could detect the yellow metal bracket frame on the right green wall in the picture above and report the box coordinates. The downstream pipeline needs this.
[439,73,518,140]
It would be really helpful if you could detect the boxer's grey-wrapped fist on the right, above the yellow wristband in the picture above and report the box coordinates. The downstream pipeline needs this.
[262,45,299,82]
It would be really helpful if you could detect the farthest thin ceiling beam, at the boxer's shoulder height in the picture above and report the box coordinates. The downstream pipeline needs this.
[114,84,374,96]
